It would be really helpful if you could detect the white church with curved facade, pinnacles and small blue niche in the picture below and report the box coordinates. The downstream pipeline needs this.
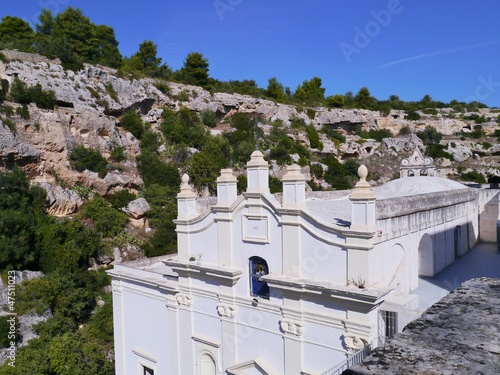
[109,151,498,375]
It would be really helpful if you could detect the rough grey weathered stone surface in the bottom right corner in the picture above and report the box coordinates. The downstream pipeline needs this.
[344,278,500,375]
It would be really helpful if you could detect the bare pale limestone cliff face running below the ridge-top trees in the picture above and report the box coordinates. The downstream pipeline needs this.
[0,51,500,215]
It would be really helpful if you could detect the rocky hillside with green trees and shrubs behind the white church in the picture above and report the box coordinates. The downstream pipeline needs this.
[0,7,500,375]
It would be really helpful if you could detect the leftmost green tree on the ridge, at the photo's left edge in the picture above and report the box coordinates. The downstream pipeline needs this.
[0,16,35,51]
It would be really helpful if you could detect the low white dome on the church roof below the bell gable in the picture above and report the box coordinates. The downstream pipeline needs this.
[373,176,468,199]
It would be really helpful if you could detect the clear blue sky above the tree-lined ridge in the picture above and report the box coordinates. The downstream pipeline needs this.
[0,0,500,107]
